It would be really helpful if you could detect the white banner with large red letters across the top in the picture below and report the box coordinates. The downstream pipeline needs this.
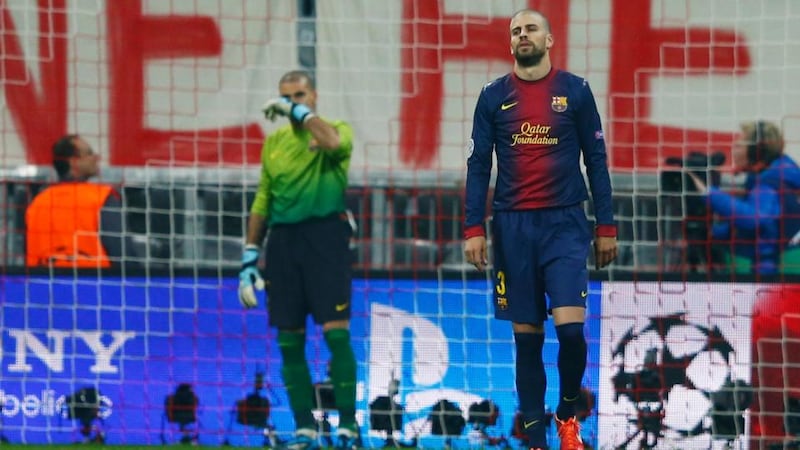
[0,0,800,173]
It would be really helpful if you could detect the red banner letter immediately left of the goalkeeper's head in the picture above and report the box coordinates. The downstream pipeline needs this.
[105,0,263,166]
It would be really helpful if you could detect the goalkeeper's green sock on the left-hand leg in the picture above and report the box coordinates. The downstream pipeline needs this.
[278,331,317,430]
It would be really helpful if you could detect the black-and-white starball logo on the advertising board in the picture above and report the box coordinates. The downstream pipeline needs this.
[611,314,752,449]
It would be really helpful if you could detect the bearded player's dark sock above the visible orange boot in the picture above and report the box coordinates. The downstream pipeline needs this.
[556,323,586,420]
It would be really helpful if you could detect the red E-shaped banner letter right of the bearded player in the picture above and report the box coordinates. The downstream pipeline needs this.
[608,0,750,169]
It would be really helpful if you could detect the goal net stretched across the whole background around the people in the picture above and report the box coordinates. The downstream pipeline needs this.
[0,0,800,449]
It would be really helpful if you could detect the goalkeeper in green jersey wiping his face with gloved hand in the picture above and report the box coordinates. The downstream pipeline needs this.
[239,71,360,449]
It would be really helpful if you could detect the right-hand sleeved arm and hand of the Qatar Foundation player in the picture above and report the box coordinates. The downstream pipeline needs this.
[576,80,617,268]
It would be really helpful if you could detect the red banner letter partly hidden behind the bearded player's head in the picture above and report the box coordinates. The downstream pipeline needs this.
[399,0,569,168]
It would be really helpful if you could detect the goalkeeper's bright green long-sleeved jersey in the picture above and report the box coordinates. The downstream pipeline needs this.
[250,121,353,225]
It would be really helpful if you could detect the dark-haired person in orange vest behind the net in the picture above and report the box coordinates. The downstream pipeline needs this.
[25,134,130,268]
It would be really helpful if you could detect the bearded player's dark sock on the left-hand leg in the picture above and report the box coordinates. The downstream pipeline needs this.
[514,333,547,447]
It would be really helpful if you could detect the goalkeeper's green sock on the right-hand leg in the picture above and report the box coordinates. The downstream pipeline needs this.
[325,329,357,431]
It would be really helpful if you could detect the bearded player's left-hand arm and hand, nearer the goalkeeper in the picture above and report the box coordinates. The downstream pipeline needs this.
[464,85,494,270]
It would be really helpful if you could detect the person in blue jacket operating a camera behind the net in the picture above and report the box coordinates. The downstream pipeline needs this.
[688,121,800,275]
